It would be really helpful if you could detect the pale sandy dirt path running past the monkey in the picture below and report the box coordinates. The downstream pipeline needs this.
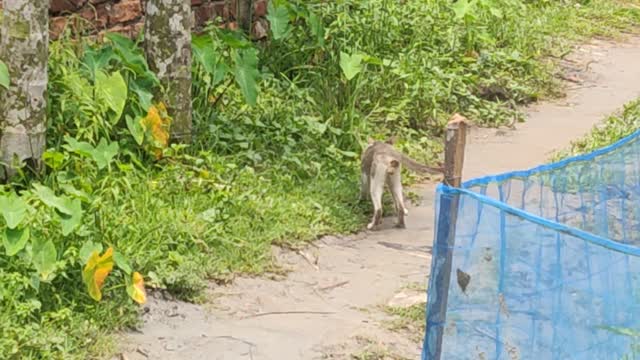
[119,38,640,360]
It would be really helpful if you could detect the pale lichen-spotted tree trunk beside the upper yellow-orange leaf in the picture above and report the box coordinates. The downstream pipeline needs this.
[145,0,193,143]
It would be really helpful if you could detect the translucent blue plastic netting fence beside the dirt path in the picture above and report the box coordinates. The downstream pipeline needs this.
[422,132,640,360]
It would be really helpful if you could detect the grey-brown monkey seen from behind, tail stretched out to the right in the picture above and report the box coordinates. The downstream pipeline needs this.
[358,138,443,230]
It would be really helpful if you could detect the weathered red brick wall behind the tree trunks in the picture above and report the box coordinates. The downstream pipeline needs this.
[0,0,267,38]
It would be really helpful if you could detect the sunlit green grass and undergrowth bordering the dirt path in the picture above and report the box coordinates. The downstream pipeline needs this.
[0,0,640,359]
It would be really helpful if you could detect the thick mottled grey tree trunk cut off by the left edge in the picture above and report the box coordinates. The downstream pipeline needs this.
[0,0,49,178]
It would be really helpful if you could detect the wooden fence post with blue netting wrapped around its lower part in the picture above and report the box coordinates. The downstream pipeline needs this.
[424,114,467,360]
